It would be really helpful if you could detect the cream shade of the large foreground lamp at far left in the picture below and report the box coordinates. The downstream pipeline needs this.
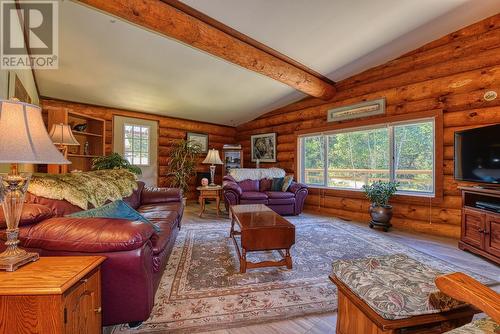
[0,100,71,165]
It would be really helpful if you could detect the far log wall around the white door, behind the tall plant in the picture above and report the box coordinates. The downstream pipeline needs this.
[41,98,236,199]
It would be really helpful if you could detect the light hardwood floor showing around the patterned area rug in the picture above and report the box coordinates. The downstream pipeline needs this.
[106,202,500,334]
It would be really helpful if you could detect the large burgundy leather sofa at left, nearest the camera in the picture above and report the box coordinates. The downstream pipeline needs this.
[0,182,184,326]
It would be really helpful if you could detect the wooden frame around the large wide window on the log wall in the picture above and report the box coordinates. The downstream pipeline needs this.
[295,110,444,203]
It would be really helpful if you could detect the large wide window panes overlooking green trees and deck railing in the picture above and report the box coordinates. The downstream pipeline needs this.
[300,119,435,195]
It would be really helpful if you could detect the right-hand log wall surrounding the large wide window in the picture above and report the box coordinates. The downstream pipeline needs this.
[237,14,500,238]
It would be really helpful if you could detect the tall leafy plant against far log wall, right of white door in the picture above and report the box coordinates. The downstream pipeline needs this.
[167,139,202,201]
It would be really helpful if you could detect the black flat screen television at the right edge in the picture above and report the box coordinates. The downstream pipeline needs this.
[455,124,500,184]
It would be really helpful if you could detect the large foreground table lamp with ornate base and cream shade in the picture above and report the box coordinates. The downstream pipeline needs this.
[0,100,70,271]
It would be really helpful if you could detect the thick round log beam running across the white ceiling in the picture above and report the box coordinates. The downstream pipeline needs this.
[76,0,335,100]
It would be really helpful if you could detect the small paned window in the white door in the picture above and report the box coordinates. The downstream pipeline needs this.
[124,124,150,166]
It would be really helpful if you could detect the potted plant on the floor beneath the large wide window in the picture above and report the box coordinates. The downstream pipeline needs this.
[363,181,399,232]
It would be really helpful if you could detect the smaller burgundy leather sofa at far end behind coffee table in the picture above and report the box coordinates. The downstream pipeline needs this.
[222,175,308,216]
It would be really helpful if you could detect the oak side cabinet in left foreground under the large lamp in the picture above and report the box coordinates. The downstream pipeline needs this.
[0,256,105,334]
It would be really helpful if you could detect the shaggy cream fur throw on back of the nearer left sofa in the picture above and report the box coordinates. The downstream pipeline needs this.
[28,169,137,210]
